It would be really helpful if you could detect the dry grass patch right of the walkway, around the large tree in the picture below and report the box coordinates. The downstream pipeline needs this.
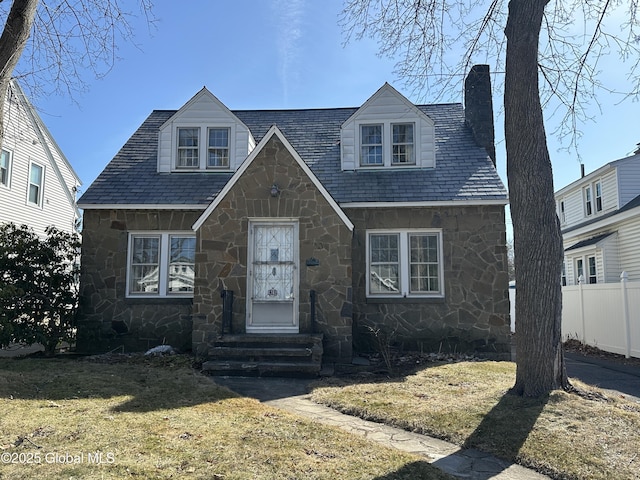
[313,362,640,480]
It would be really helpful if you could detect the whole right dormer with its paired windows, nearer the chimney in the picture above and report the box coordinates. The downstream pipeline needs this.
[340,83,436,170]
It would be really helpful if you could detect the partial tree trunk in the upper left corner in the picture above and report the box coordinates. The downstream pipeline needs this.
[0,0,39,145]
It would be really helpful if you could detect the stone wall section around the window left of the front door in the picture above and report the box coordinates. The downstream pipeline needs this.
[77,210,201,352]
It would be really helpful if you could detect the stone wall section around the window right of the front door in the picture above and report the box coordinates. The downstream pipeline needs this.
[345,206,510,358]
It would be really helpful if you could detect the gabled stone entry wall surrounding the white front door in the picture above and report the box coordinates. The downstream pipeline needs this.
[193,136,352,362]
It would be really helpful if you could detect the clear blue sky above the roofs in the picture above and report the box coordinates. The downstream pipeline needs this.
[27,0,640,212]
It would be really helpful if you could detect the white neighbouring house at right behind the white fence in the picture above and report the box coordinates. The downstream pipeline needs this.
[555,149,640,285]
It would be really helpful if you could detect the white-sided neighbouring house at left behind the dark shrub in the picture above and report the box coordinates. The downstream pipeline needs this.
[0,80,81,236]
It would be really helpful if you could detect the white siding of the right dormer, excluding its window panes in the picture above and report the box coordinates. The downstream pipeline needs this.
[340,84,435,170]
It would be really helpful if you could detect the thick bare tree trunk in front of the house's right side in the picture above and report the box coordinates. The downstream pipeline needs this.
[504,0,570,397]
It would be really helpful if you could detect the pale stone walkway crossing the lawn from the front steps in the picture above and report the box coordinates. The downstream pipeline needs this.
[213,377,549,480]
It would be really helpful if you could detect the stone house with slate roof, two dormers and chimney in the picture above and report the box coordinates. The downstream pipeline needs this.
[78,66,510,369]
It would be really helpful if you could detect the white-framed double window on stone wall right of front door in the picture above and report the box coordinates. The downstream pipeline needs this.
[367,230,444,297]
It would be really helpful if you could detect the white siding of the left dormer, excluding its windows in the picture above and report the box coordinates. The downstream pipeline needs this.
[158,89,255,172]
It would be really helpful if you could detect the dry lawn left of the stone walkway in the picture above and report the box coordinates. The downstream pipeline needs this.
[0,357,451,480]
